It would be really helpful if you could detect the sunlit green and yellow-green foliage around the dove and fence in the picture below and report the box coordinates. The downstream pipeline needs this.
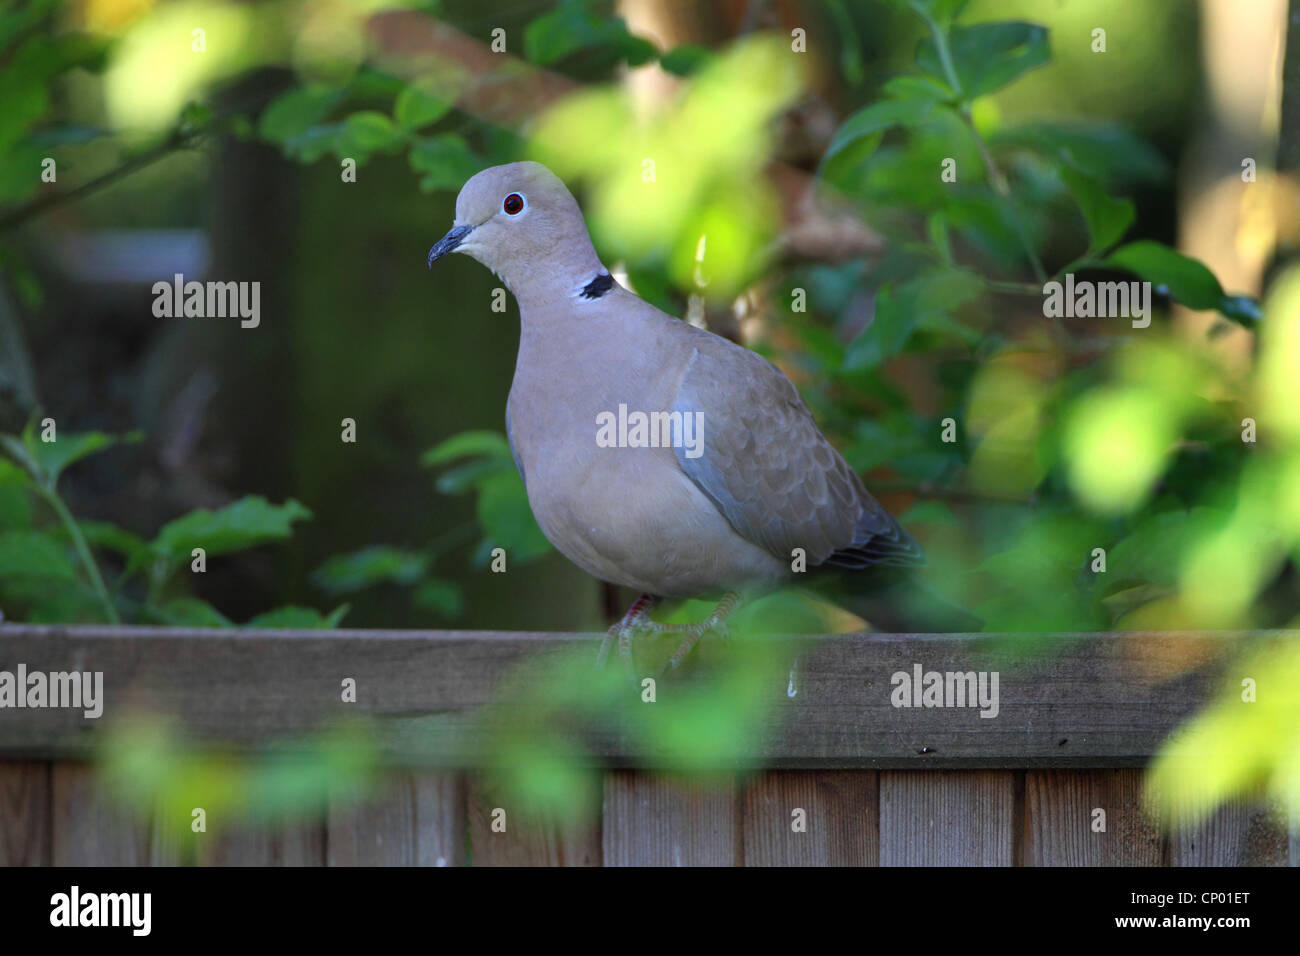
[0,0,1300,837]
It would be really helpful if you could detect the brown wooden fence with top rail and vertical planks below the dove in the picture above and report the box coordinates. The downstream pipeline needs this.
[0,624,1300,866]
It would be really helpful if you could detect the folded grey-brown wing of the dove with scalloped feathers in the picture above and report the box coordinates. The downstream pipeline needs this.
[673,339,924,568]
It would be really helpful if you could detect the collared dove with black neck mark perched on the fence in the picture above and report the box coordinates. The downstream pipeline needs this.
[429,163,977,667]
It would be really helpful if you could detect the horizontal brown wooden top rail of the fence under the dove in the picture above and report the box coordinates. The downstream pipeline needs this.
[0,624,1284,770]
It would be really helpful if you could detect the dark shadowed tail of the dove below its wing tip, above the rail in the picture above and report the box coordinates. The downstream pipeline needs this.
[816,567,984,633]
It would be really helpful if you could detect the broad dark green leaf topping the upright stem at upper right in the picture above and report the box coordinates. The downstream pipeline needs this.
[917,21,1052,100]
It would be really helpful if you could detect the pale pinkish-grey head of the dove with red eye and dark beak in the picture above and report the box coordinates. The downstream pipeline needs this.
[429,163,606,299]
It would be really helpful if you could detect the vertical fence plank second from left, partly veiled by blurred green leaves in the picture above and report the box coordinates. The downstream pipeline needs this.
[49,762,153,866]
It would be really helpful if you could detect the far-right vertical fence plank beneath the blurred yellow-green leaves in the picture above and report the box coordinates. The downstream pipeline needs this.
[1169,800,1288,866]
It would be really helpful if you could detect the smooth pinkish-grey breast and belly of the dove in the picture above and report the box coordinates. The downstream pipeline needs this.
[507,304,788,597]
